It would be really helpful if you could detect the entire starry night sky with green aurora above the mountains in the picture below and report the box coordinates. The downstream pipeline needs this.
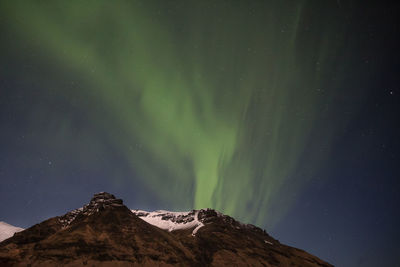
[0,0,400,267]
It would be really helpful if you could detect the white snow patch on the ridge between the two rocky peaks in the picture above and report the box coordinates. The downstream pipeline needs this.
[132,210,204,236]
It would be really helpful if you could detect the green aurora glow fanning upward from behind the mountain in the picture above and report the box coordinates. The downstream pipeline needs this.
[0,1,354,225]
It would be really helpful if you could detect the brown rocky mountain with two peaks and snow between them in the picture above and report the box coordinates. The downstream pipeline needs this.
[0,192,332,267]
